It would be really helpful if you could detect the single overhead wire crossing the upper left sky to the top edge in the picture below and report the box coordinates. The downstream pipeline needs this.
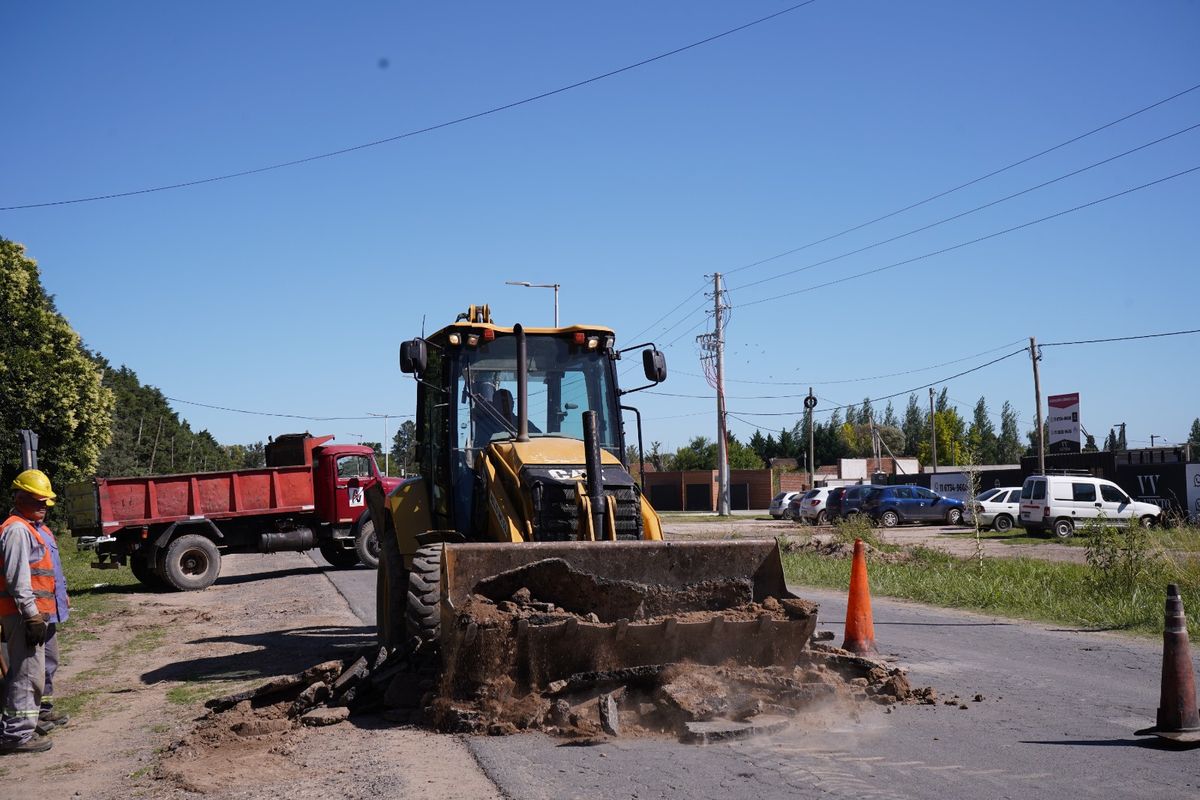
[0,0,816,211]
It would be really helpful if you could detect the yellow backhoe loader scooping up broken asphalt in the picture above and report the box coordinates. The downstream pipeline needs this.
[367,306,816,688]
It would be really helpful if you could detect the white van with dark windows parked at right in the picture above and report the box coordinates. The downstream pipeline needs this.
[1021,475,1163,539]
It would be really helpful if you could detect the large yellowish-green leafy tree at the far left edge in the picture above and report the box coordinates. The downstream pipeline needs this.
[0,239,114,487]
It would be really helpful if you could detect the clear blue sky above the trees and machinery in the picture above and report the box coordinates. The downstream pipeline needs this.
[0,0,1200,450]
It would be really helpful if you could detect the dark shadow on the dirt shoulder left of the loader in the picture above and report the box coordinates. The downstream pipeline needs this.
[142,623,376,684]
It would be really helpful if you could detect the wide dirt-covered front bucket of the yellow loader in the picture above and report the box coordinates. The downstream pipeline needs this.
[442,542,816,697]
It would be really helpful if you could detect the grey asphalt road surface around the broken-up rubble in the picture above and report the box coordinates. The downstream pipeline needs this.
[314,555,1200,800]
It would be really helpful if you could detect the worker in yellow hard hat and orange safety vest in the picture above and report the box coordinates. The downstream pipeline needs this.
[0,469,66,754]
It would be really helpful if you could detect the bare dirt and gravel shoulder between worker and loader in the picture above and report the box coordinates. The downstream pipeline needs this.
[0,553,502,800]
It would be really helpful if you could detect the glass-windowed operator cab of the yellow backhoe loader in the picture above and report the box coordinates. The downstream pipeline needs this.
[401,317,665,539]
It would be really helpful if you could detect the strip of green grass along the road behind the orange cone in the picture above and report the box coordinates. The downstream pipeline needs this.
[784,534,1200,639]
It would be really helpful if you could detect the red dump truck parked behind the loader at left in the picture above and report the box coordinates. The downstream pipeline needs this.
[64,433,403,591]
